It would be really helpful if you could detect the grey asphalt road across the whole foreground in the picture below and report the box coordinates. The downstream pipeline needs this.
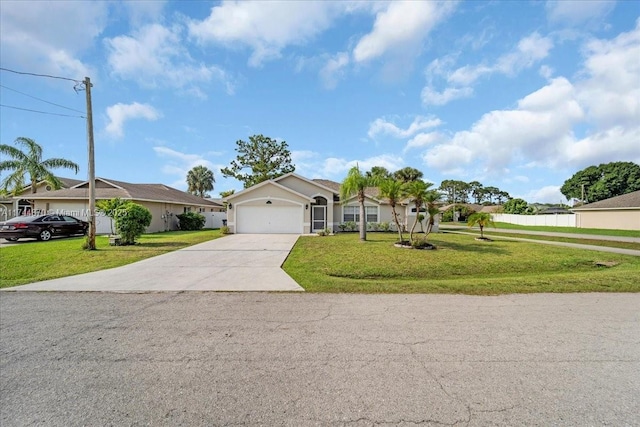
[0,292,640,427]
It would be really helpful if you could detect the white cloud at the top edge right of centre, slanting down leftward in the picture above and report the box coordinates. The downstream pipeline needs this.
[353,1,456,62]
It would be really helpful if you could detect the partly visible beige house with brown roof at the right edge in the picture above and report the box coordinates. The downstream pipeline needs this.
[571,191,640,231]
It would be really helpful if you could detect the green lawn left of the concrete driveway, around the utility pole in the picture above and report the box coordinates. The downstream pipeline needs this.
[0,230,222,288]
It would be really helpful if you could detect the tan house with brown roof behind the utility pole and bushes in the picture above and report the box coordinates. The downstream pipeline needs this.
[15,178,222,234]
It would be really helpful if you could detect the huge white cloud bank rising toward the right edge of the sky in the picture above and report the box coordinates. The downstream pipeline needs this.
[423,20,640,179]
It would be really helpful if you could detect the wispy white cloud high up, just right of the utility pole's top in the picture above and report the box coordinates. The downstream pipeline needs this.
[105,24,234,98]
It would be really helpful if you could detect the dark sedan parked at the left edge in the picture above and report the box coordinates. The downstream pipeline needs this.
[0,215,89,242]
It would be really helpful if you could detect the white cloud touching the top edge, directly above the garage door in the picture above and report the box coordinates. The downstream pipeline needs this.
[189,1,347,67]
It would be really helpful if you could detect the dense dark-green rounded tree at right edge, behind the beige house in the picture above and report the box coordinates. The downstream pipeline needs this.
[560,162,640,203]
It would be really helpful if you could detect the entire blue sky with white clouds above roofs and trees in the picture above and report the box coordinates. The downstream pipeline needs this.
[0,0,640,203]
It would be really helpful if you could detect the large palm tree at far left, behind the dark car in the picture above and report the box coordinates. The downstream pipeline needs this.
[0,136,80,196]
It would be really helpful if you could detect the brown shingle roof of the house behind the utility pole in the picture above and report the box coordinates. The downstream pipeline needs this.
[23,178,221,207]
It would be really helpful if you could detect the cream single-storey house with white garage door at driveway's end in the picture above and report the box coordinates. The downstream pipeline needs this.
[224,173,432,234]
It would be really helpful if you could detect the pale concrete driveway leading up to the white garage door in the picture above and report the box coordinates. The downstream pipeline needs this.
[7,234,304,292]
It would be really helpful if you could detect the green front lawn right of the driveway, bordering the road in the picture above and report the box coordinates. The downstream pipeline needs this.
[284,233,640,295]
